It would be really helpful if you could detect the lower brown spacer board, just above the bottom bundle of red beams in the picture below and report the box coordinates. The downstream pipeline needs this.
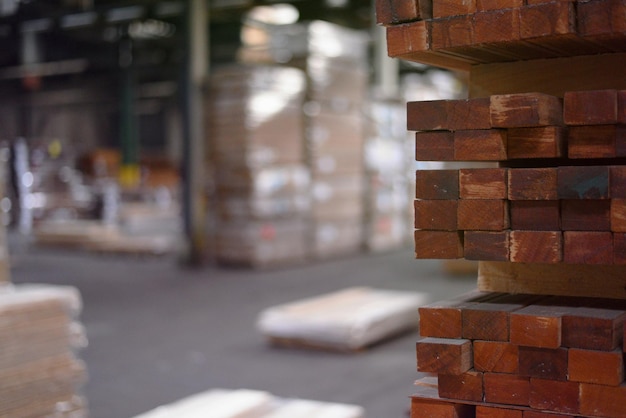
[477,261,626,299]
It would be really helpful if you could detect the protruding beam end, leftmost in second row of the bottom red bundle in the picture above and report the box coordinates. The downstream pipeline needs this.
[416,337,473,375]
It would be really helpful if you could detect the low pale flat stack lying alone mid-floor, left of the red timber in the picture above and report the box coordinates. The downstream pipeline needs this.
[257,287,427,350]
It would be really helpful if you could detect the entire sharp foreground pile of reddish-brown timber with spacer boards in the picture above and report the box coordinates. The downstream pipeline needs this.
[377,0,626,418]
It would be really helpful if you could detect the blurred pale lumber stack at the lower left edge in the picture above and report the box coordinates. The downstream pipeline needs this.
[0,285,87,418]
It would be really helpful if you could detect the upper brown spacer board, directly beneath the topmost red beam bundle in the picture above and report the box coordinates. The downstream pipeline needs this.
[469,52,626,96]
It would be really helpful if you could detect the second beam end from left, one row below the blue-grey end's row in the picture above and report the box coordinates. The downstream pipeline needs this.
[458,199,509,231]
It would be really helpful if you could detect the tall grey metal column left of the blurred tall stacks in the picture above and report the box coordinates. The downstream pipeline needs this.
[181,0,209,266]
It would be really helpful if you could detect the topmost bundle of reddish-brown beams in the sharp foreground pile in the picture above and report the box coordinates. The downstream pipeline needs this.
[376,0,626,69]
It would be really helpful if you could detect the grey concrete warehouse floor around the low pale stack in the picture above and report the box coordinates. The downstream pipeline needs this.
[12,240,476,418]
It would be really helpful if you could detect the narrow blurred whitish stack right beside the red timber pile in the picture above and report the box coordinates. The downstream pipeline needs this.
[365,99,414,251]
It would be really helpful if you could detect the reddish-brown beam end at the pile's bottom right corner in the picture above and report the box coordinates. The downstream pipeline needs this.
[580,383,626,418]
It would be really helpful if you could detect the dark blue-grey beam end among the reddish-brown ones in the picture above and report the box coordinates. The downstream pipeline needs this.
[557,166,610,199]
